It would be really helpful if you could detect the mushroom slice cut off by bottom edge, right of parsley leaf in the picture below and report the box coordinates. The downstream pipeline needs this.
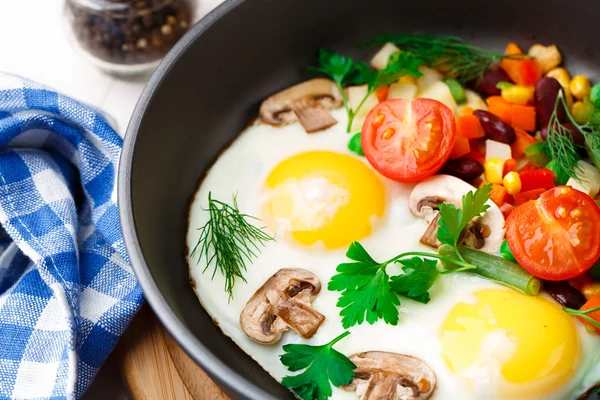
[342,351,436,400]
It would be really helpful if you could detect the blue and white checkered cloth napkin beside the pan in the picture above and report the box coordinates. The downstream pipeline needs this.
[0,74,143,399]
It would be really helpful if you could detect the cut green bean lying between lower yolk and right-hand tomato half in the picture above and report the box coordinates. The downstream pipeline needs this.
[438,244,542,296]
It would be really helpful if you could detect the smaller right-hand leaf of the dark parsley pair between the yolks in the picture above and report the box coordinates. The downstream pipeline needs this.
[390,257,440,304]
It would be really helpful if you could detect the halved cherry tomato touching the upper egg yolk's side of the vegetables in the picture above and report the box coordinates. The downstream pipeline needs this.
[362,99,456,182]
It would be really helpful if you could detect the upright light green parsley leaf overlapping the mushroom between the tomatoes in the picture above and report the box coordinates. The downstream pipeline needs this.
[438,184,492,247]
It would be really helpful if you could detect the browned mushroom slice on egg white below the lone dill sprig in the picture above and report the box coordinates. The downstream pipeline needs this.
[240,268,325,344]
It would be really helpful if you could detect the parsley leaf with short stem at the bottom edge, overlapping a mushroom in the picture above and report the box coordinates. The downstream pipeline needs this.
[280,332,356,400]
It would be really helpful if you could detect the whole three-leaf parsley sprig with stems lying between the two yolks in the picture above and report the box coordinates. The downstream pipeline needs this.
[327,185,491,329]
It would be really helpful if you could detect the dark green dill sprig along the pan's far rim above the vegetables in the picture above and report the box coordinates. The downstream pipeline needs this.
[365,33,528,84]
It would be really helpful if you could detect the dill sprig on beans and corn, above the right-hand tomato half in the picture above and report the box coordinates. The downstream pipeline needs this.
[544,90,582,181]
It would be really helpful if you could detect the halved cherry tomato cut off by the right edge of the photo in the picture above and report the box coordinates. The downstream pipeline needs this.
[506,186,600,281]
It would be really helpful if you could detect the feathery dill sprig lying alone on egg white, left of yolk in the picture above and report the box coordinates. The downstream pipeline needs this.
[191,192,274,300]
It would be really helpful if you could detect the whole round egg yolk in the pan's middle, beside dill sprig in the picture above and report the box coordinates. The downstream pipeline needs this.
[263,151,385,249]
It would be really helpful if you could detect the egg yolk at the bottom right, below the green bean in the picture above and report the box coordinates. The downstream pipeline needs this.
[441,289,579,399]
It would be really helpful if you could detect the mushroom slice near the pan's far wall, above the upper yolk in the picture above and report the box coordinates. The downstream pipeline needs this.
[260,78,342,133]
